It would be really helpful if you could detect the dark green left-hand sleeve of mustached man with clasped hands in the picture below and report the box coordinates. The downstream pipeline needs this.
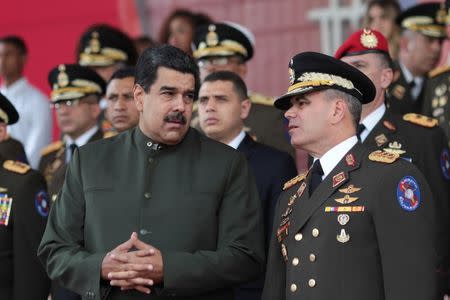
[38,151,106,299]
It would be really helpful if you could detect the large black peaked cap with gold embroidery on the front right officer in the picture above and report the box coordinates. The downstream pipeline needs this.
[274,52,375,110]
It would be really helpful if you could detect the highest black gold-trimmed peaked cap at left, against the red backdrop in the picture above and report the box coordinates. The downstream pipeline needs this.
[78,24,138,67]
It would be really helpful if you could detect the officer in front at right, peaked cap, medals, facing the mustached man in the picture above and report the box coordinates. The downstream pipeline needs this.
[263,52,439,300]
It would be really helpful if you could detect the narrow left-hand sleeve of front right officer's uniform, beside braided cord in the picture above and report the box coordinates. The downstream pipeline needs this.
[262,196,286,300]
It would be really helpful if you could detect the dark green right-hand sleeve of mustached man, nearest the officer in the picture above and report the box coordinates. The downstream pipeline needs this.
[161,155,265,296]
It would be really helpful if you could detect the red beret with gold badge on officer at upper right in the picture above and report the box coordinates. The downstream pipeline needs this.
[334,28,389,59]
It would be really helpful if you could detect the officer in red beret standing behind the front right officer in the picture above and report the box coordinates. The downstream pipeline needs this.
[335,29,450,292]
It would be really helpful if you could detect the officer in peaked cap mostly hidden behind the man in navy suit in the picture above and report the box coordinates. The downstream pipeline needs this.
[192,23,294,155]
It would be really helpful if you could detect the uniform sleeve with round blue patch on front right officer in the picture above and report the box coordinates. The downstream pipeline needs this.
[373,161,438,300]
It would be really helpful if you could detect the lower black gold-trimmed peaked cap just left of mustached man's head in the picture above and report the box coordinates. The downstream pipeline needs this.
[48,64,105,102]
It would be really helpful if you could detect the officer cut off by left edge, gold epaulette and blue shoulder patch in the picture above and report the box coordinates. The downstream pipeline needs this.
[0,95,50,300]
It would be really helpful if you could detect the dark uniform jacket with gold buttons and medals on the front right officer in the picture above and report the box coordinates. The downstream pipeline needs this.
[263,144,439,300]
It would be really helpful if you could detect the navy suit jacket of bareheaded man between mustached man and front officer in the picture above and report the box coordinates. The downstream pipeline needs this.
[235,134,297,300]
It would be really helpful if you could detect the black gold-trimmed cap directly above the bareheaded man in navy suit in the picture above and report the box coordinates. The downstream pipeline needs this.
[192,23,254,61]
